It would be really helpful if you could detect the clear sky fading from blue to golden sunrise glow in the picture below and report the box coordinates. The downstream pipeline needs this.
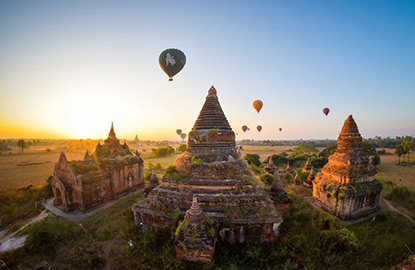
[0,0,415,140]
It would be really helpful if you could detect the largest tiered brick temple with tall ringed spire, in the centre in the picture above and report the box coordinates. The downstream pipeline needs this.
[132,86,282,260]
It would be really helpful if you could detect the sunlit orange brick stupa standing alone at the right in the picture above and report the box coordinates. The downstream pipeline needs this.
[313,115,382,219]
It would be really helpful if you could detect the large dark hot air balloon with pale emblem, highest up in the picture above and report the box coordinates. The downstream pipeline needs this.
[159,49,186,81]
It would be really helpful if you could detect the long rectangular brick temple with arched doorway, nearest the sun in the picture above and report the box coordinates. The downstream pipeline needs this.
[51,125,144,211]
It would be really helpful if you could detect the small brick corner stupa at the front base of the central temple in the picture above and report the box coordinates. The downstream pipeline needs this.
[174,196,216,263]
